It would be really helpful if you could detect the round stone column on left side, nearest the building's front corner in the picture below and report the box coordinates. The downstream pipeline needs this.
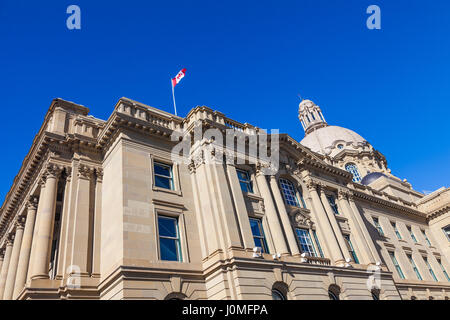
[31,165,61,279]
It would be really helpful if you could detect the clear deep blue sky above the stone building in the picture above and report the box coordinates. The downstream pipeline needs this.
[0,0,450,202]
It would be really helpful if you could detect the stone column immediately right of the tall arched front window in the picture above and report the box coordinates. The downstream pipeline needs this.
[306,179,345,265]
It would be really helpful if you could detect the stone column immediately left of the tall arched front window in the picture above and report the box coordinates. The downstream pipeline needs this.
[256,169,289,255]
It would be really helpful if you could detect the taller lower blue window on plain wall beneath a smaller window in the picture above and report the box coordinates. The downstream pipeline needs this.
[158,216,182,261]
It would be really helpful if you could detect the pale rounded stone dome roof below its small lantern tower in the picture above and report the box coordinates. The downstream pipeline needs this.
[300,126,369,156]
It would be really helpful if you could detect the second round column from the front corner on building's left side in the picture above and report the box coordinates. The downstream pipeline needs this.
[13,196,38,299]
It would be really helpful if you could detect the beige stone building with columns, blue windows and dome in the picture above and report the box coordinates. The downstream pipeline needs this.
[0,98,450,300]
